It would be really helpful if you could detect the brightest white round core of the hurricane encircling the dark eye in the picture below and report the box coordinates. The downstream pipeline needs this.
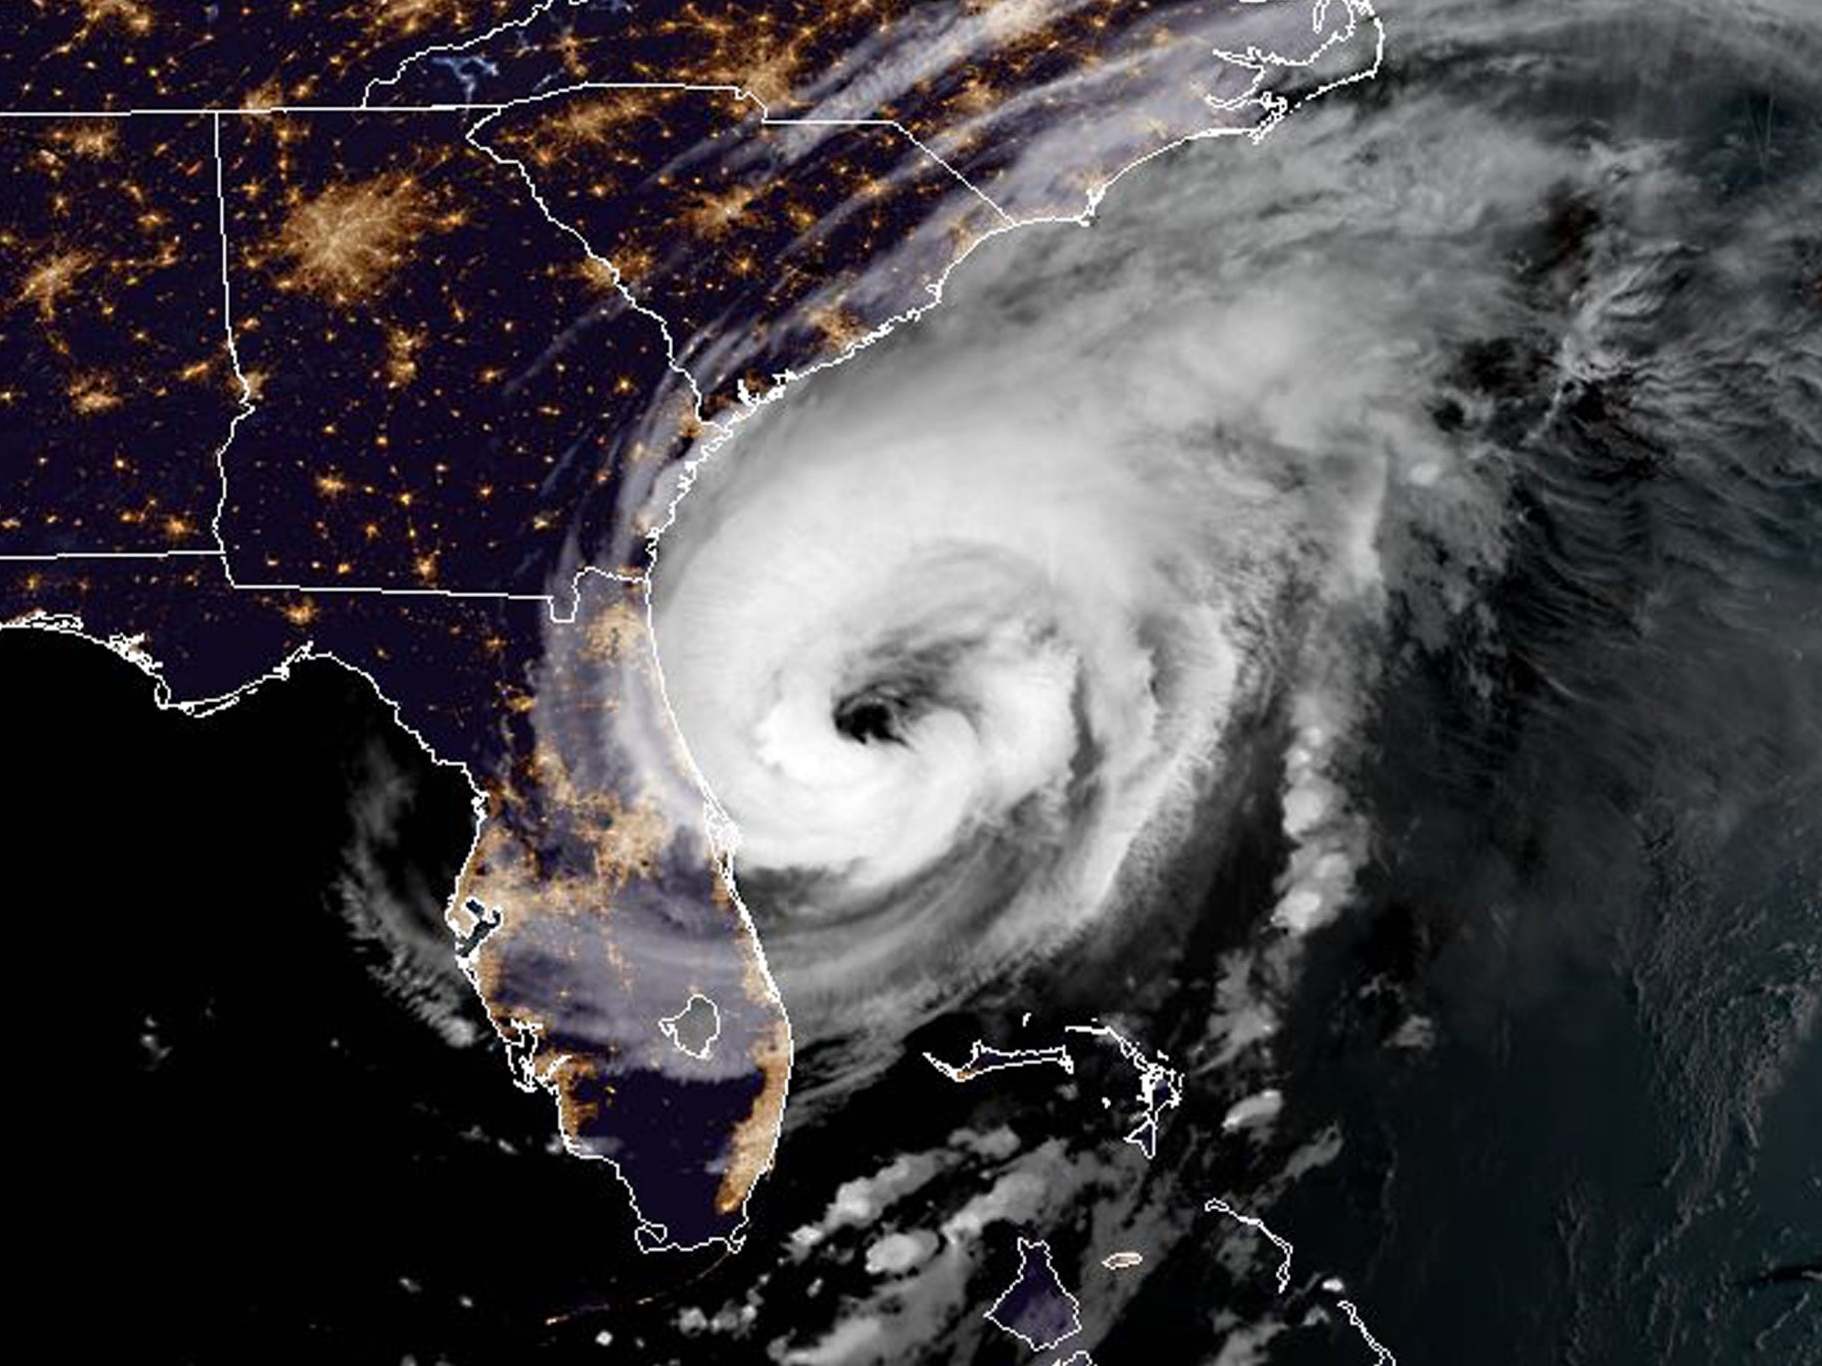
[660,353,1232,900]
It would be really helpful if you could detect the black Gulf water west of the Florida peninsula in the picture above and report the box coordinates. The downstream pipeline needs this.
[0,632,656,1361]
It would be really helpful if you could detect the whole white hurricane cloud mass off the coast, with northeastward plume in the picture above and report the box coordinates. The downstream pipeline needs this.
[654,122,1508,1063]
